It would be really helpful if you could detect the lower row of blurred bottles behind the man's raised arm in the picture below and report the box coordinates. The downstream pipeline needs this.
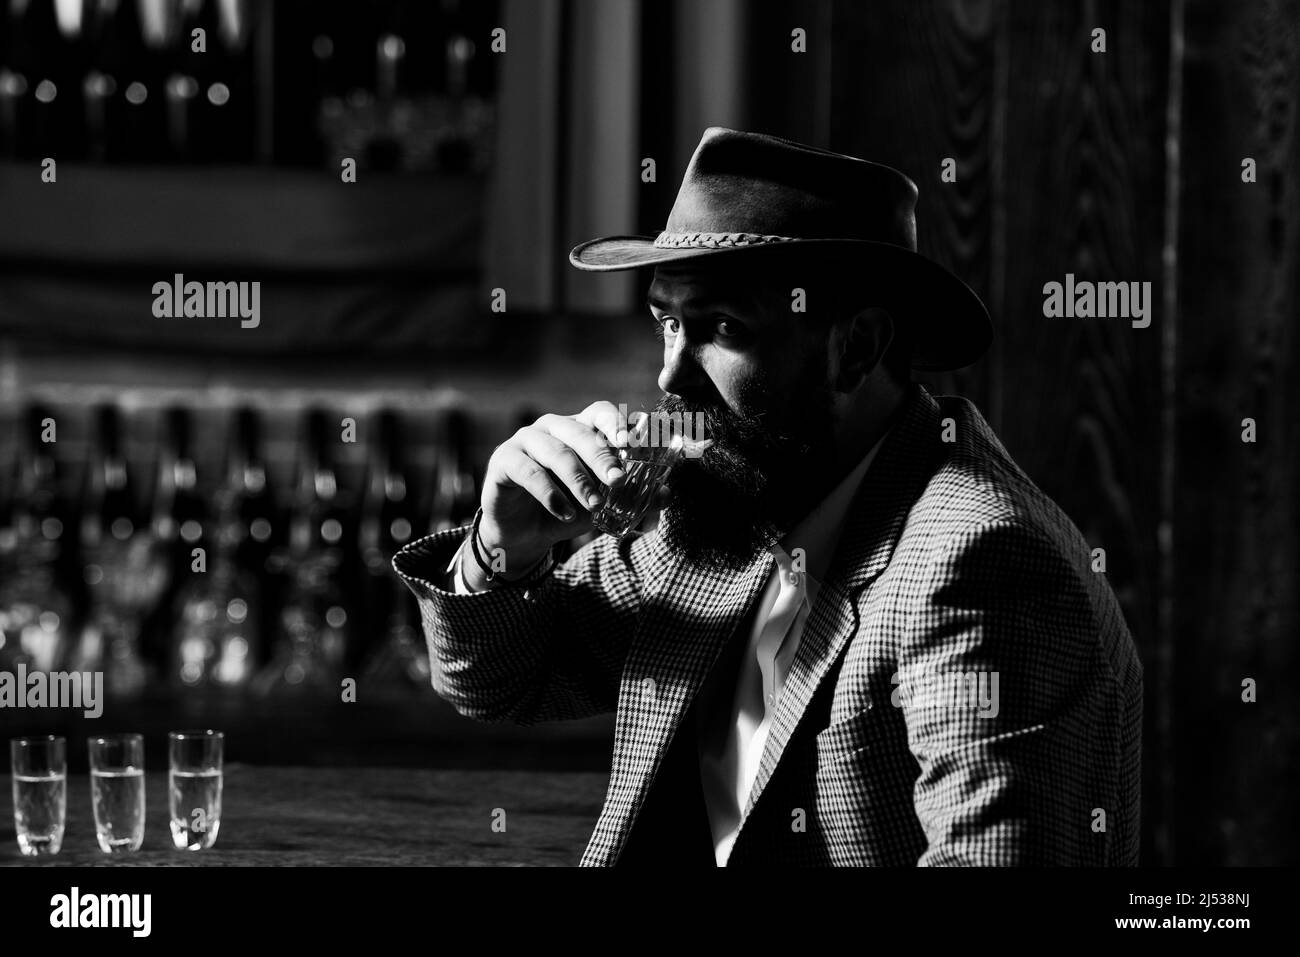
[0,395,581,700]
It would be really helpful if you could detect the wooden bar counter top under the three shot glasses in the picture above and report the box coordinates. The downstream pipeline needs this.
[0,763,608,867]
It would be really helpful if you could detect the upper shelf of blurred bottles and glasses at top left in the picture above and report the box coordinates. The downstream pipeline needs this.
[0,0,498,173]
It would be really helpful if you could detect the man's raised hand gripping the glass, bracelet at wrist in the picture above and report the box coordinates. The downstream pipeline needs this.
[462,402,650,592]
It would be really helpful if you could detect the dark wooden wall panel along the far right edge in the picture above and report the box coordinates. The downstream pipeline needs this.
[1174,0,1300,865]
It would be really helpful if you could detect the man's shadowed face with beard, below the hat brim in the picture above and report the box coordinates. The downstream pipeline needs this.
[646,260,835,570]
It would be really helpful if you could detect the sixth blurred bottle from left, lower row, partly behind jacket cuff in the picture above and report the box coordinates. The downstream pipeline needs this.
[359,410,430,690]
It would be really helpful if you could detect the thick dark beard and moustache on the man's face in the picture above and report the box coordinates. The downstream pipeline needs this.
[655,374,835,572]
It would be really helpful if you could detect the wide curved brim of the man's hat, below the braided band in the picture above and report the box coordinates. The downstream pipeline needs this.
[569,235,993,372]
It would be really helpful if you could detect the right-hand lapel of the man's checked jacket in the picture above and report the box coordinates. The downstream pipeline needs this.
[737,384,943,826]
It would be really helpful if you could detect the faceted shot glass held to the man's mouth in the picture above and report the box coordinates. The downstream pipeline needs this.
[592,411,712,538]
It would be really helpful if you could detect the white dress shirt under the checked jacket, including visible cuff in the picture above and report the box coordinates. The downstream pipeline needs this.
[447,433,888,867]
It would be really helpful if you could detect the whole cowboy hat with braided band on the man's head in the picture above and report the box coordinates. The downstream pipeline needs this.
[569,126,993,371]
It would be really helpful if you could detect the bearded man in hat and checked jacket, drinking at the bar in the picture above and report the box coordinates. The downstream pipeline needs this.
[394,127,1143,866]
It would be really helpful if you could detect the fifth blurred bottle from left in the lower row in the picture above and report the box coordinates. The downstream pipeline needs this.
[256,410,351,694]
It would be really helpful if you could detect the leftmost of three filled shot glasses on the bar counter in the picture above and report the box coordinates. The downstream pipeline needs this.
[9,735,68,857]
